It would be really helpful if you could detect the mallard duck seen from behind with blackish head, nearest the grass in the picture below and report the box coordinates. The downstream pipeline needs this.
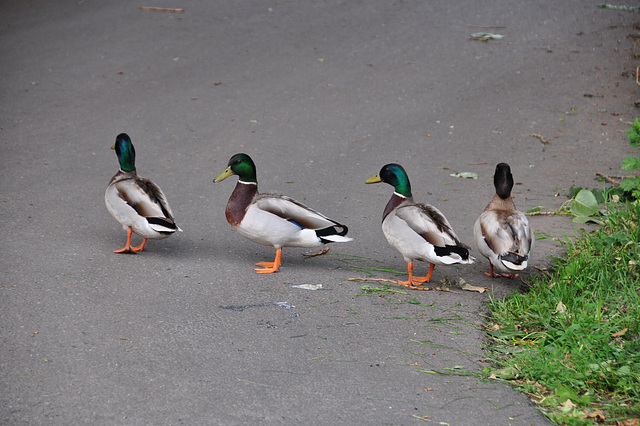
[473,163,534,278]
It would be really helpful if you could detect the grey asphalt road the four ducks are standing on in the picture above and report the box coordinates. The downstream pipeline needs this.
[0,0,639,425]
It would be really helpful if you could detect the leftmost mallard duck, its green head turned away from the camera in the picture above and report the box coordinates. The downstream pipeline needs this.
[104,133,182,253]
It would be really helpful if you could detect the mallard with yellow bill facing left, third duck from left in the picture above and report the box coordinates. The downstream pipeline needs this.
[365,164,474,287]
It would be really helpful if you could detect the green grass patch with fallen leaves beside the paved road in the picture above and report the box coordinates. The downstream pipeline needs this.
[485,201,640,425]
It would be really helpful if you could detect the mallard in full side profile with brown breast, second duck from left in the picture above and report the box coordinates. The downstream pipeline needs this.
[213,154,352,274]
